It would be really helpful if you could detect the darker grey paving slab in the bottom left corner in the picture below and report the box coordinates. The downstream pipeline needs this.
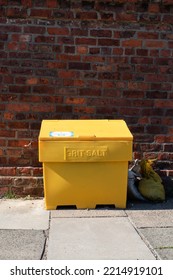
[0,230,45,260]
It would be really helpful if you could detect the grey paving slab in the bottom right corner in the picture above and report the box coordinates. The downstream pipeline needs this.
[140,227,173,260]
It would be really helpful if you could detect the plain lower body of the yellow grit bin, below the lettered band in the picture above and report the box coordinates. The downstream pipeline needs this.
[43,162,128,210]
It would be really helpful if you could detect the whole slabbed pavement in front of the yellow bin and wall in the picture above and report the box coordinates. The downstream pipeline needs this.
[0,198,173,260]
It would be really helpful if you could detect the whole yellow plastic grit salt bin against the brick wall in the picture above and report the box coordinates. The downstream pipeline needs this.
[39,120,133,210]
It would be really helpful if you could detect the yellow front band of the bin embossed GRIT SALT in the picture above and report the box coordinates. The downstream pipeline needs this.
[39,141,132,162]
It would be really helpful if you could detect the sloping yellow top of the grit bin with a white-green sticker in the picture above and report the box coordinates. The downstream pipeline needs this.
[39,120,133,141]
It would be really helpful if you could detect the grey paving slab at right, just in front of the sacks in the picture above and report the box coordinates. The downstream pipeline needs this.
[126,209,173,228]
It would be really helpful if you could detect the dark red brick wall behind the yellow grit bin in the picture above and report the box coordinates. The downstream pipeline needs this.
[0,0,173,197]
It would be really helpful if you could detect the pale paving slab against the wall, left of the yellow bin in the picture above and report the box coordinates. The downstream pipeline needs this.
[0,199,49,230]
